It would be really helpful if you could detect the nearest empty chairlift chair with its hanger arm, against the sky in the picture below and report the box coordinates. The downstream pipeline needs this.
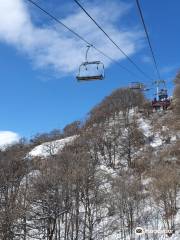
[76,46,105,81]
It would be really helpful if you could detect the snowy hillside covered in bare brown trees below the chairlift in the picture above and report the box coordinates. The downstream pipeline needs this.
[0,89,180,240]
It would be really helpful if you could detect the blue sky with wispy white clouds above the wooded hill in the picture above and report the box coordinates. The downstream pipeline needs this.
[0,0,180,142]
